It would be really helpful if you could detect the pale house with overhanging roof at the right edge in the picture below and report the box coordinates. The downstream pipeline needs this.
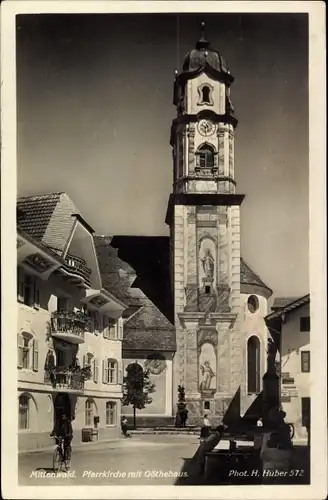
[266,295,311,444]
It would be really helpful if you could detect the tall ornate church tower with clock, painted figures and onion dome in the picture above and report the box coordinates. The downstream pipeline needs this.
[166,24,244,424]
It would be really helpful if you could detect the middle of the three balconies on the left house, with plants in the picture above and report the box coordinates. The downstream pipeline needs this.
[50,311,90,344]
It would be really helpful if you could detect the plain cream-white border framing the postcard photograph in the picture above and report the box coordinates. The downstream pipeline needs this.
[1,0,327,500]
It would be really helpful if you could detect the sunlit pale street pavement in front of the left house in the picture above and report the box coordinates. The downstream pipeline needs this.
[18,436,199,486]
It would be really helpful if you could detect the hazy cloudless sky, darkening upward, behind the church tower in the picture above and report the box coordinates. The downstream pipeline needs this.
[16,13,309,296]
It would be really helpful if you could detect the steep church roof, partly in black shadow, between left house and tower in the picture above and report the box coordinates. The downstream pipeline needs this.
[94,236,176,352]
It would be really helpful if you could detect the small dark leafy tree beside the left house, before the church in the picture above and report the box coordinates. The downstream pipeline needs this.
[122,361,155,429]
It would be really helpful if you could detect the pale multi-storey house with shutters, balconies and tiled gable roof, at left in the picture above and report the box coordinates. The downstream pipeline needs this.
[17,193,126,451]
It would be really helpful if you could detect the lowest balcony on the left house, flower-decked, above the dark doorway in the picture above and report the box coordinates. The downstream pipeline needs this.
[44,366,89,392]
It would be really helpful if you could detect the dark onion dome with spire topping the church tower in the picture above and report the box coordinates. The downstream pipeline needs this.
[183,23,230,74]
